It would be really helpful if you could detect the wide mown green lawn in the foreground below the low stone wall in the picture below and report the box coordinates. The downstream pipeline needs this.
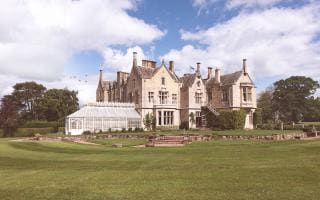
[0,139,320,200]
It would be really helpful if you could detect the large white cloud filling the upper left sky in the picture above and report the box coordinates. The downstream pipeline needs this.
[0,0,165,103]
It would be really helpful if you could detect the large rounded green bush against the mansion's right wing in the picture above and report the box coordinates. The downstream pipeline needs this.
[218,110,246,129]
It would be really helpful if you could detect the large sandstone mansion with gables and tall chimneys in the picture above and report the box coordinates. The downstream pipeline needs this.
[96,52,256,129]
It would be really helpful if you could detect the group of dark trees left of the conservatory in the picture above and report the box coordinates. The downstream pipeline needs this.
[0,82,79,135]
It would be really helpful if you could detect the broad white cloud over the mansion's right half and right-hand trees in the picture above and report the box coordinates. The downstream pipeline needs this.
[164,4,320,79]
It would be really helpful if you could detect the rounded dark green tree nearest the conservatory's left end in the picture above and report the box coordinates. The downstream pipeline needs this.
[39,89,79,121]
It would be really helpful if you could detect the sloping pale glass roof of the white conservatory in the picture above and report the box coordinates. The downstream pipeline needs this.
[68,102,141,119]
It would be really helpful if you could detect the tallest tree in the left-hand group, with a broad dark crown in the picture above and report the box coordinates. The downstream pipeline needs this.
[12,82,46,120]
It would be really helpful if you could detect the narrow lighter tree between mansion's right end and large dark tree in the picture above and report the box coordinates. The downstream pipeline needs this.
[257,88,273,123]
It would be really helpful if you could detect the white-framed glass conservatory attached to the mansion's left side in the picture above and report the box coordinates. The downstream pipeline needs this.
[65,102,141,135]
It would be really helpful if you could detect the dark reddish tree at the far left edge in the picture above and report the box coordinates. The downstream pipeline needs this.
[0,95,20,136]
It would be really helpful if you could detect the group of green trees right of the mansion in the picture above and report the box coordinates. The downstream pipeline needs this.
[256,76,320,123]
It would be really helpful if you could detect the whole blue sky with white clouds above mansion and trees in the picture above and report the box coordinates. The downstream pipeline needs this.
[0,0,320,104]
